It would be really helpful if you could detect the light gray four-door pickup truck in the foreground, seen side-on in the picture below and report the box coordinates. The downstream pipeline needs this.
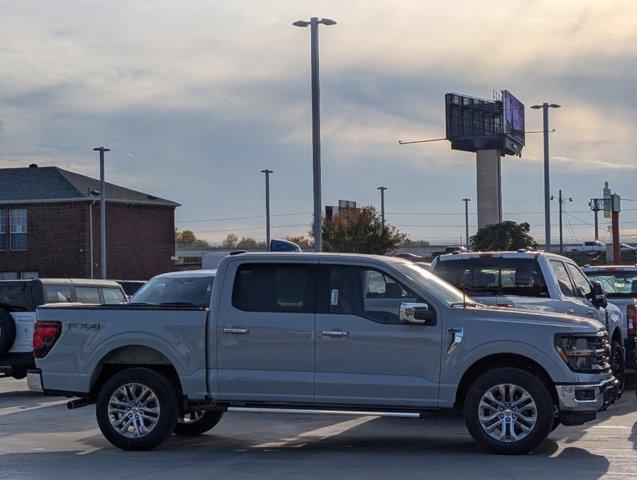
[28,253,617,454]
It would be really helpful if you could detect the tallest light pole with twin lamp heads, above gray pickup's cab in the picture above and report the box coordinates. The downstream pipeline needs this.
[292,17,336,252]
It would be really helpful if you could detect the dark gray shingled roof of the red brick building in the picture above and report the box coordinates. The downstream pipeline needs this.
[0,166,179,207]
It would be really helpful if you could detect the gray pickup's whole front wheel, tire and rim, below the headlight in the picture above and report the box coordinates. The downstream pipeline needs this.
[464,368,555,455]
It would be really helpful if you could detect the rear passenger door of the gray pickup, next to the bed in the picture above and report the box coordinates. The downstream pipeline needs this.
[212,262,316,403]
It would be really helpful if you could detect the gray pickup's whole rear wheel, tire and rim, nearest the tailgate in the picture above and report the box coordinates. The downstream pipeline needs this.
[96,368,179,450]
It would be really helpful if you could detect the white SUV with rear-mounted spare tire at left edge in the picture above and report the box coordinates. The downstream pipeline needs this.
[0,278,125,378]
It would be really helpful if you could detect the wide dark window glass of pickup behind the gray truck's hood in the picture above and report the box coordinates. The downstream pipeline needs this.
[434,257,548,297]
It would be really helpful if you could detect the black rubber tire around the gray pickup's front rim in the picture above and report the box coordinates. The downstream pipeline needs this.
[464,367,555,455]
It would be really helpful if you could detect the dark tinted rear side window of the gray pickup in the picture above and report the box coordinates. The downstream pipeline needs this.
[232,263,316,313]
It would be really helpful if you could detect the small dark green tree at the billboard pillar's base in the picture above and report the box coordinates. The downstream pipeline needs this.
[470,221,538,252]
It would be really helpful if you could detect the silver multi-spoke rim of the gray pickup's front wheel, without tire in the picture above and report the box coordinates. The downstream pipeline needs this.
[478,383,537,443]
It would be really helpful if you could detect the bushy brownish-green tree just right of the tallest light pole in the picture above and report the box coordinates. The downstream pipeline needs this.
[323,206,406,255]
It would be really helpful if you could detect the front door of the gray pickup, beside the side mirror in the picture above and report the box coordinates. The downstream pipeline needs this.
[314,264,441,407]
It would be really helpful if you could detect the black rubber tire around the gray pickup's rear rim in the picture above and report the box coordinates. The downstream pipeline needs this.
[95,368,179,450]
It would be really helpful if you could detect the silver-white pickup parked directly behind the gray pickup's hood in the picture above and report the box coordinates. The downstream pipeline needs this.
[432,252,626,394]
